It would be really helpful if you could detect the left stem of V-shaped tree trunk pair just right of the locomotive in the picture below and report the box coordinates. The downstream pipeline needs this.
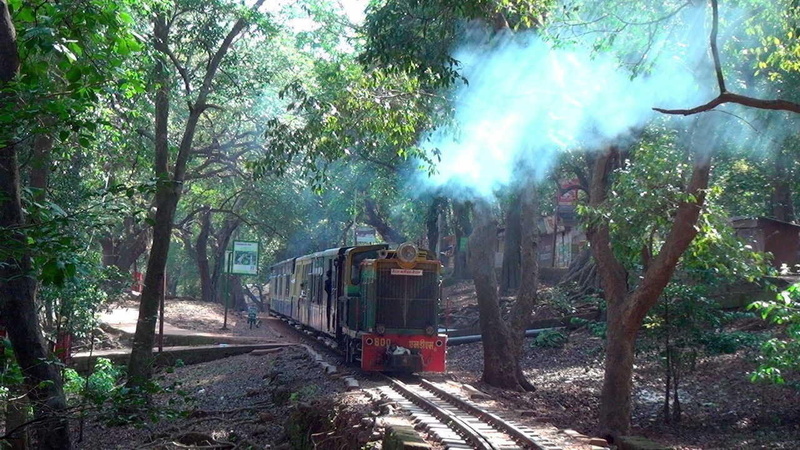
[469,202,522,390]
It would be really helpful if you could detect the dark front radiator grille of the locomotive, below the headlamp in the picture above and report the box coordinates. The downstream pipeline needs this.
[375,267,439,329]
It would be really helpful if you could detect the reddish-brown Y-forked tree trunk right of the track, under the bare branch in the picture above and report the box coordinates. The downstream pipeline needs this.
[587,137,711,436]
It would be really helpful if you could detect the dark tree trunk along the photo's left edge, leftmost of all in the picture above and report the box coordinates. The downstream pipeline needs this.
[0,0,72,449]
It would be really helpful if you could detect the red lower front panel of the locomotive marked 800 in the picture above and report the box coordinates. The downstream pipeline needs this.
[361,334,447,372]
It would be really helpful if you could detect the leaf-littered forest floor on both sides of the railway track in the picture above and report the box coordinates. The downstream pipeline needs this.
[78,283,800,449]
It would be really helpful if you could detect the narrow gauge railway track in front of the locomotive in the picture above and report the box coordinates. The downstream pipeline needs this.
[382,376,560,450]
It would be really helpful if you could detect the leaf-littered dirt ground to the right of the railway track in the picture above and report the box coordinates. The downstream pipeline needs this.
[445,283,800,449]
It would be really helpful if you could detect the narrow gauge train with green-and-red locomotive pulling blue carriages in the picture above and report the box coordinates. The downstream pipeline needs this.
[269,243,447,372]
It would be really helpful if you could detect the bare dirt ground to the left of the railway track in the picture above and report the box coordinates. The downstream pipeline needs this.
[73,300,374,450]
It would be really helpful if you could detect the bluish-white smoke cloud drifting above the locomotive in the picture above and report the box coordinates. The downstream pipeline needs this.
[424,1,715,196]
